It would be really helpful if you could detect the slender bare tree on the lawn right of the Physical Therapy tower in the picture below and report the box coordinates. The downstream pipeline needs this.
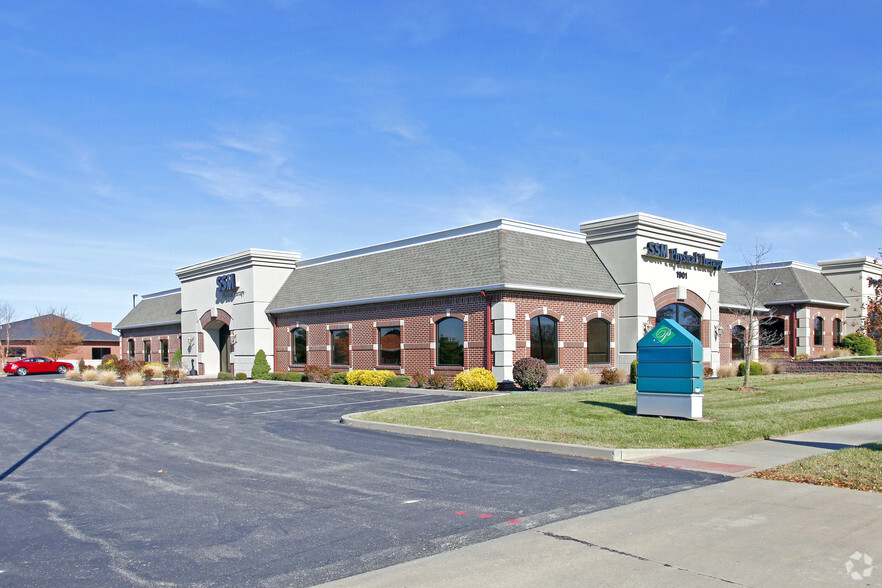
[735,242,783,388]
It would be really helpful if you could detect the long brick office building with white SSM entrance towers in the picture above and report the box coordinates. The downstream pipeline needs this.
[117,213,880,381]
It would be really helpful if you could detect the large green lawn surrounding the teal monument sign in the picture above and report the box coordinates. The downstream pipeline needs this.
[360,374,882,448]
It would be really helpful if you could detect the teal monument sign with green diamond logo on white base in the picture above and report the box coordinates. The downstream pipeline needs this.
[637,319,704,419]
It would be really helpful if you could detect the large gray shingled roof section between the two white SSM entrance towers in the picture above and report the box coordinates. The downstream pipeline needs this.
[267,229,621,312]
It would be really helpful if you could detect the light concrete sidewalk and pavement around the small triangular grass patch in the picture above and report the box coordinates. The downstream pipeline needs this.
[328,421,882,588]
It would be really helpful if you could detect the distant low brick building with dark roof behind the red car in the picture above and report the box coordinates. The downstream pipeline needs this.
[0,315,119,361]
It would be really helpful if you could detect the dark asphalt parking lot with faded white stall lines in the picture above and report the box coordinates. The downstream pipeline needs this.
[0,376,727,586]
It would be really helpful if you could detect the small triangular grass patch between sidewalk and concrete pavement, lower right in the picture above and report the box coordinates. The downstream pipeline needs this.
[751,441,882,492]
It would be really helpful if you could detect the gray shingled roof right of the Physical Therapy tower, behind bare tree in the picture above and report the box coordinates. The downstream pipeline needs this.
[720,264,848,308]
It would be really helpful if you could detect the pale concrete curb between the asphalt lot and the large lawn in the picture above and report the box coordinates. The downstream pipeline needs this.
[340,413,691,461]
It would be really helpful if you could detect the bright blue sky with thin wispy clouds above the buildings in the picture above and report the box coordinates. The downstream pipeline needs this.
[0,0,882,323]
